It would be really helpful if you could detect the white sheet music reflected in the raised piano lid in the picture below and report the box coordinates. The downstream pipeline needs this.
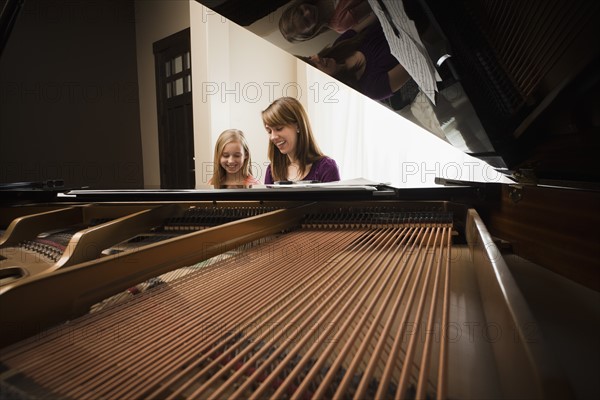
[369,0,442,104]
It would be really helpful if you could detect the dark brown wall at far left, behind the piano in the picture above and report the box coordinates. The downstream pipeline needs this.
[0,0,143,189]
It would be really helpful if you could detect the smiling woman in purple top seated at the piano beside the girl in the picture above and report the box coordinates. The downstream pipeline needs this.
[262,97,340,184]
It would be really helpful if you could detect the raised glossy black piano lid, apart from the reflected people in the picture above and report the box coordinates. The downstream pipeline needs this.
[197,0,600,188]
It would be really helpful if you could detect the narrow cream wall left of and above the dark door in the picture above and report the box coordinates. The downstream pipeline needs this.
[135,0,189,188]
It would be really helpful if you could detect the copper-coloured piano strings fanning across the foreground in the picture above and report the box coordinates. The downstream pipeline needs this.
[2,213,452,399]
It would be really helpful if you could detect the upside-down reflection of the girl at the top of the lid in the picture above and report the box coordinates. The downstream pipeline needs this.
[279,0,372,42]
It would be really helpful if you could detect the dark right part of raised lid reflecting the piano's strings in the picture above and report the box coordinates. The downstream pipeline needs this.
[425,0,600,183]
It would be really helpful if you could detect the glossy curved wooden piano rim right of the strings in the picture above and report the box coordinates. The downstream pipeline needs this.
[466,209,573,399]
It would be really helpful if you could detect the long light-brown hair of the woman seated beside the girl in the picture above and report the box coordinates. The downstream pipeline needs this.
[262,97,324,181]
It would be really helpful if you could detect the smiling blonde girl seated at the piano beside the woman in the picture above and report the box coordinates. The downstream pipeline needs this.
[208,129,259,187]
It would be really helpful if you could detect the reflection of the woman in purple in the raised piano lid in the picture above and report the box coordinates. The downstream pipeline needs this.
[299,22,410,100]
